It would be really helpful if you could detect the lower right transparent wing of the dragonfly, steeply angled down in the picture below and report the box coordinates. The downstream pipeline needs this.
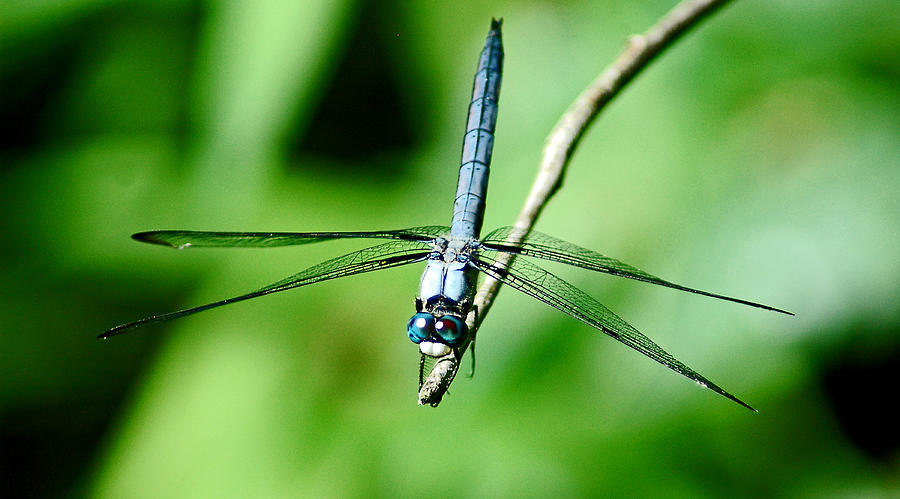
[472,252,756,411]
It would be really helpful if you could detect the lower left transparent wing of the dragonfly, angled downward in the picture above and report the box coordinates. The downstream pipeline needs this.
[98,241,430,338]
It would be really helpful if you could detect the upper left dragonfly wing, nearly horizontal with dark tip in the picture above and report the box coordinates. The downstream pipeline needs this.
[131,225,450,249]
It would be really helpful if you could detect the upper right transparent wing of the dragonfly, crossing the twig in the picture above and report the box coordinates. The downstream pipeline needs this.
[481,227,794,315]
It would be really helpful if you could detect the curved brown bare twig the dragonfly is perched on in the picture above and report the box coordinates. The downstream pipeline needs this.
[419,0,728,406]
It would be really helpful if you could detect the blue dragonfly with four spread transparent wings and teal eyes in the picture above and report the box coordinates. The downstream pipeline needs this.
[99,19,793,411]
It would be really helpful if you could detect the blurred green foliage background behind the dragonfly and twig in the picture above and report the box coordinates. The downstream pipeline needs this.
[0,0,900,498]
